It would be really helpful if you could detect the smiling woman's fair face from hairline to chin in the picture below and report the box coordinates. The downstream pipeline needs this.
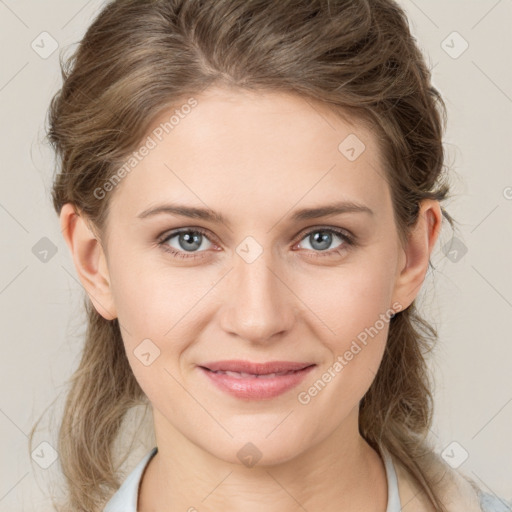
[90,89,410,464]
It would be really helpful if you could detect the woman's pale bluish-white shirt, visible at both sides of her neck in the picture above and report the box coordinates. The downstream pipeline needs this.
[103,446,512,512]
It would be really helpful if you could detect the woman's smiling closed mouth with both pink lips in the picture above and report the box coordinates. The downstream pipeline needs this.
[198,361,316,400]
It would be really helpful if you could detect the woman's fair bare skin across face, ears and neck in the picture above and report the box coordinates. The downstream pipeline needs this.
[61,88,441,512]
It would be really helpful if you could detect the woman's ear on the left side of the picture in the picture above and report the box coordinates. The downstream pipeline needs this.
[60,203,117,320]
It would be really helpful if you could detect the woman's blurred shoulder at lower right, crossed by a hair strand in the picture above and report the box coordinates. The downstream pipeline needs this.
[393,453,512,512]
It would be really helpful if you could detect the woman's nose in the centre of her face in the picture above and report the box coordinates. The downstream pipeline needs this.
[221,244,297,344]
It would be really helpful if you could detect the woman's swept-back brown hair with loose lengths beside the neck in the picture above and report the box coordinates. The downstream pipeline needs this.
[31,0,453,512]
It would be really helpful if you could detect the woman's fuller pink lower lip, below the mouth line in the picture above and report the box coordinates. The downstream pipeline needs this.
[199,365,314,400]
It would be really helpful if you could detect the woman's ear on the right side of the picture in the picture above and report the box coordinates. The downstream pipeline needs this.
[392,199,443,310]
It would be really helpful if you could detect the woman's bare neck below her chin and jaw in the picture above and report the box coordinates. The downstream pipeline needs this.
[137,411,387,512]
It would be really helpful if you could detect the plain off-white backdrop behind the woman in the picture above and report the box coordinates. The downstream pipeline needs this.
[0,0,512,512]
